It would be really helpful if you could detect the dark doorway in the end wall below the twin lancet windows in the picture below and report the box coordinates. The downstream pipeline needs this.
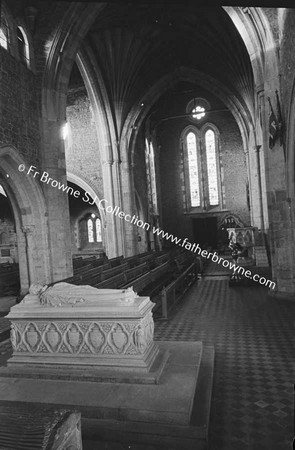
[193,217,217,248]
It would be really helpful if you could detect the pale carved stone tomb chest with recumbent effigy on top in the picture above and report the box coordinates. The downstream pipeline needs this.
[7,283,159,372]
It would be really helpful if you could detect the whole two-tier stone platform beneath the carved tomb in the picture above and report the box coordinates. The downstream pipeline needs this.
[0,341,214,450]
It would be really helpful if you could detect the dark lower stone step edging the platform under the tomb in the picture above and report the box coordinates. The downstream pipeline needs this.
[82,346,214,450]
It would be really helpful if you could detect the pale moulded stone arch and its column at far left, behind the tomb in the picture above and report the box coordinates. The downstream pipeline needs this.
[0,145,52,293]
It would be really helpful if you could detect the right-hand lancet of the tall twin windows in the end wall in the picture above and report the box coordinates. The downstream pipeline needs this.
[205,130,219,206]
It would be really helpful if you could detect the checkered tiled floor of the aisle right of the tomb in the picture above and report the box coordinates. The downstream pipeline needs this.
[0,265,295,450]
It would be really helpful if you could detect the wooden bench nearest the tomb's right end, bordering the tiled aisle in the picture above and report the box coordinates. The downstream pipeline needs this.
[161,262,198,319]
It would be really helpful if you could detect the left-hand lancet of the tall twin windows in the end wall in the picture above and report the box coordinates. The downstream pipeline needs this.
[186,132,200,207]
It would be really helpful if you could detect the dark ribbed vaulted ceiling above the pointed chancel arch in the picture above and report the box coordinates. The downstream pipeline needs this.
[71,3,253,134]
